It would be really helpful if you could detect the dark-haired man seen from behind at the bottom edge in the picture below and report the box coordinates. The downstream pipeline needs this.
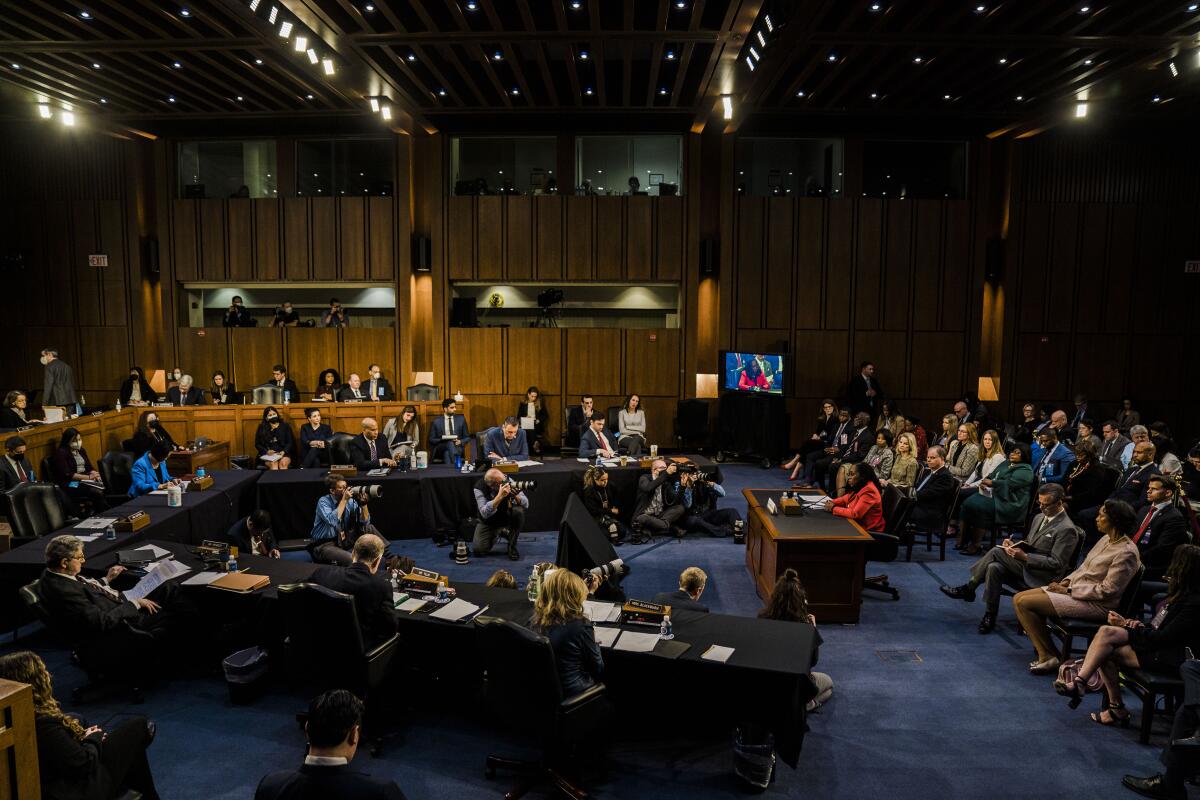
[254,688,404,800]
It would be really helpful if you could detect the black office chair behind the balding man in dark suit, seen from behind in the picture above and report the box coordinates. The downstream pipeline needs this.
[278,583,400,756]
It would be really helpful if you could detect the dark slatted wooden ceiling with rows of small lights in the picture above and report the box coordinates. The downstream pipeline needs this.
[0,0,1200,133]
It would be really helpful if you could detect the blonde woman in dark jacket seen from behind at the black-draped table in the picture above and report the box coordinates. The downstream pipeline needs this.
[532,570,604,698]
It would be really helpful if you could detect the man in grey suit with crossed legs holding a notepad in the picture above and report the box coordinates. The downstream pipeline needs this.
[941,483,1081,633]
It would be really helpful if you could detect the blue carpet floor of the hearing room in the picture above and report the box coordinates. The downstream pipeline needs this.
[4,465,1168,800]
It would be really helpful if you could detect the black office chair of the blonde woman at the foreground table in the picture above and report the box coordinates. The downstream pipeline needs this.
[475,616,608,800]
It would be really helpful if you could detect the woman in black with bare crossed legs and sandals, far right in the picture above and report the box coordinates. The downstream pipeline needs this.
[1055,545,1200,734]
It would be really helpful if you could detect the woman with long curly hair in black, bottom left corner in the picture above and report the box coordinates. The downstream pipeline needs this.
[0,650,158,800]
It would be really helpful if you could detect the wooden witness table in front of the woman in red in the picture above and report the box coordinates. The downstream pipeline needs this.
[742,489,872,622]
